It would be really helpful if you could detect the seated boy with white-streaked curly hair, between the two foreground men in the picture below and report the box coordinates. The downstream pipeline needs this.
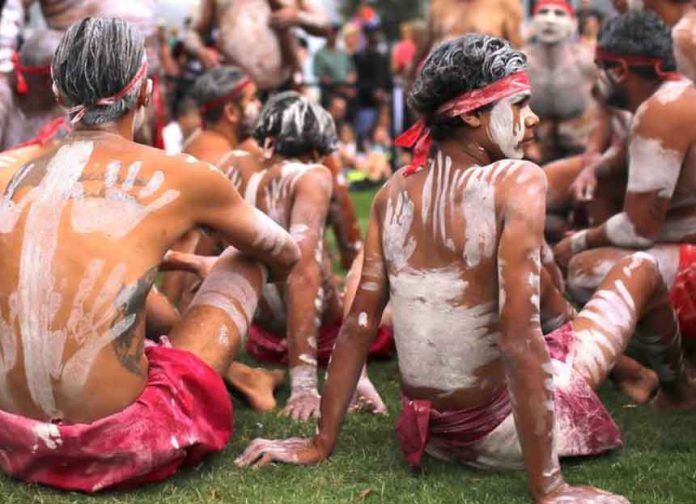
[237,91,386,421]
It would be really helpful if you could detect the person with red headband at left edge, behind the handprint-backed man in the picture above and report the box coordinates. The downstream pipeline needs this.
[0,30,70,151]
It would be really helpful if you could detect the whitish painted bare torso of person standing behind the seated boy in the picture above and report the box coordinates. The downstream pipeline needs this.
[215,0,296,89]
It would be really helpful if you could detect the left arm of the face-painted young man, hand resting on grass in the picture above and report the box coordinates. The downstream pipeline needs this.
[232,195,389,466]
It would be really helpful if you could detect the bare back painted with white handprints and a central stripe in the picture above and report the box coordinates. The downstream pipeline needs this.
[0,134,206,422]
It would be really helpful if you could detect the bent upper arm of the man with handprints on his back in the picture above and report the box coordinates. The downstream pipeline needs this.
[188,163,299,281]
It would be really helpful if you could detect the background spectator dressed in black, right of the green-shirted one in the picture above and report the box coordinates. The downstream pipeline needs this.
[355,28,392,142]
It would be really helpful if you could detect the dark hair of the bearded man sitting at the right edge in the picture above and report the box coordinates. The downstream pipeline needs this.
[598,11,676,78]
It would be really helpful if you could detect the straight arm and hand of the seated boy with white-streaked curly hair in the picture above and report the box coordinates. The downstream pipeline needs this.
[285,167,331,421]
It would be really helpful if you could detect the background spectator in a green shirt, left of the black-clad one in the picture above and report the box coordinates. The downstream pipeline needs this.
[314,25,356,108]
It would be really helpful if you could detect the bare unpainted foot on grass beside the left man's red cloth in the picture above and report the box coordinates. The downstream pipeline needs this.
[227,362,285,411]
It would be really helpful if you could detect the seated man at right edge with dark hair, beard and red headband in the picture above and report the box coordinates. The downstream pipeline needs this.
[555,11,696,362]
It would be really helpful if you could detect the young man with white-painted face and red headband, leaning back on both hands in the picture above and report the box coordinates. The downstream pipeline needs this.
[237,34,696,503]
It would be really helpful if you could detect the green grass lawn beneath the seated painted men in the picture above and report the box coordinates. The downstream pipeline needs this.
[5,188,696,504]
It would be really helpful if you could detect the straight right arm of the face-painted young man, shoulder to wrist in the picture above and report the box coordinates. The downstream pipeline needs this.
[498,165,563,499]
